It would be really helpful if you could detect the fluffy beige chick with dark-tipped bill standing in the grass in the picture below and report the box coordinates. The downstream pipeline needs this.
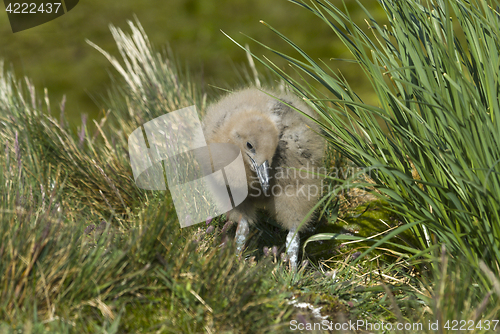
[203,88,325,269]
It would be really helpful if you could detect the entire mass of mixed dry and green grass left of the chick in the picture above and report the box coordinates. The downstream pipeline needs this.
[0,25,293,333]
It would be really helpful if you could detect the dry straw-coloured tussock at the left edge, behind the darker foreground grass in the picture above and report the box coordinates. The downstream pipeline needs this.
[0,67,140,219]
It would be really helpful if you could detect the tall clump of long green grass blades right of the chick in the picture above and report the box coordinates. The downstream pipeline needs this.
[238,0,500,324]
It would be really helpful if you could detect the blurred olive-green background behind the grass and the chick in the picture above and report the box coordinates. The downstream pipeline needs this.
[0,0,380,126]
